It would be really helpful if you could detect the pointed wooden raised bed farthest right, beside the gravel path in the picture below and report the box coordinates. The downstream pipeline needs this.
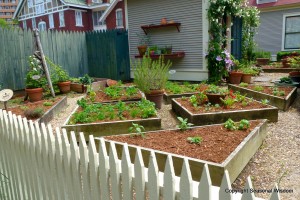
[228,85,297,111]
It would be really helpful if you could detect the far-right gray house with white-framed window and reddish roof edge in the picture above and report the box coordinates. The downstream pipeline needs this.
[249,0,300,60]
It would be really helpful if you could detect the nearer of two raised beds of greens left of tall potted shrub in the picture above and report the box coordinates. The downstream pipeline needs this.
[62,99,161,138]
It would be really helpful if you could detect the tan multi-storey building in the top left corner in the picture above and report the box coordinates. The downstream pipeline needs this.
[0,0,18,22]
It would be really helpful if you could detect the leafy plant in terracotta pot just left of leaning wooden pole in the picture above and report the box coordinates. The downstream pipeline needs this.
[25,56,47,102]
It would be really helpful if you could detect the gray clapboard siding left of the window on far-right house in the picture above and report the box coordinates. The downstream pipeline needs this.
[255,9,300,54]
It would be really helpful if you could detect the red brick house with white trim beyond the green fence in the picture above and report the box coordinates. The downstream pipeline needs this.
[13,0,126,31]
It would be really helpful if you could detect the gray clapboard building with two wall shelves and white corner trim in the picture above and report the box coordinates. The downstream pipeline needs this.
[116,0,241,81]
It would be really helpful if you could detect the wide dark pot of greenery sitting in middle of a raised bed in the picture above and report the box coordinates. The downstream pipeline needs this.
[206,85,228,104]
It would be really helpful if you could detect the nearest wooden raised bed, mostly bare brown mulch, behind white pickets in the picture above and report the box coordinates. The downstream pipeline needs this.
[105,120,267,186]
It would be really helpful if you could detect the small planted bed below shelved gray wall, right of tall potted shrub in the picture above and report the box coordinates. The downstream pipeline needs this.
[164,81,207,104]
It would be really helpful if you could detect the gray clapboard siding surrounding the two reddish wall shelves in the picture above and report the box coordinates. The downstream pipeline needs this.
[127,0,204,77]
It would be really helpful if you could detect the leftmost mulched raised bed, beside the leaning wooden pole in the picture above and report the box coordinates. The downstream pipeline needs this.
[8,96,67,123]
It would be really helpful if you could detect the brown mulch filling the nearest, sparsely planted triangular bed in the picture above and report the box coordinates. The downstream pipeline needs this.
[105,121,260,163]
